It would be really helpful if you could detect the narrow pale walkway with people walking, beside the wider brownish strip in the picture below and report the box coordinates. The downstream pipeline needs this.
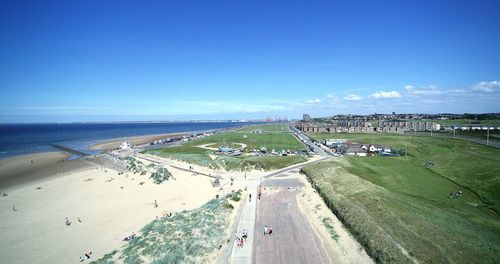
[229,179,260,264]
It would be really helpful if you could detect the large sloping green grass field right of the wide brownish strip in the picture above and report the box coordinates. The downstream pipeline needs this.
[304,134,500,263]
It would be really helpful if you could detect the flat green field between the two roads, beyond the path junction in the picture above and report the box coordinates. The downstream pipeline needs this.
[145,125,307,171]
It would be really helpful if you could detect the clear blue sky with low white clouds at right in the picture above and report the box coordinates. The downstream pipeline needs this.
[0,0,500,122]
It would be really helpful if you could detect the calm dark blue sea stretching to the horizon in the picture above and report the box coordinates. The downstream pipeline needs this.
[0,122,256,159]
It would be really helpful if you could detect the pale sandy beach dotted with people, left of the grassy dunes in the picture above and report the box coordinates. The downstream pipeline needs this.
[0,153,219,263]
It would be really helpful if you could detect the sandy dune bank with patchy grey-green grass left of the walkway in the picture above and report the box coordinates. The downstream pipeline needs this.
[92,193,239,264]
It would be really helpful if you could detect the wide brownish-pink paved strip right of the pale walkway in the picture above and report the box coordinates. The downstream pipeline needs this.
[253,179,330,263]
